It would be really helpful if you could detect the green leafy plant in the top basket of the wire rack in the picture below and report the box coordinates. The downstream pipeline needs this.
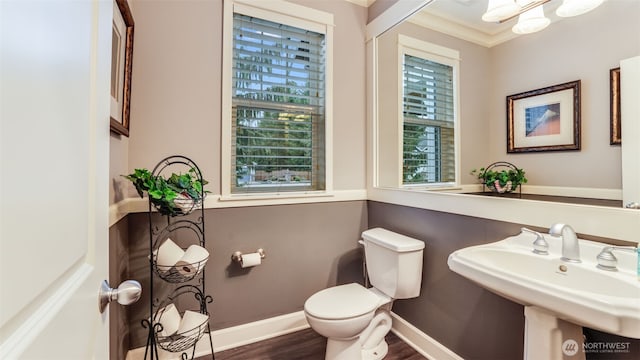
[122,168,208,216]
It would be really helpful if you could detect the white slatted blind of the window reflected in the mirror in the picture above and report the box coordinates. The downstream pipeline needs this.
[402,54,455,184]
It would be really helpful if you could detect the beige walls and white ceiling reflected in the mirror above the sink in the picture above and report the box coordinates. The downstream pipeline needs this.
[374,0,640,206]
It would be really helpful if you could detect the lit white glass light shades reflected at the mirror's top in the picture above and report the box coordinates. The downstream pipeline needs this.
[482,0,605,34]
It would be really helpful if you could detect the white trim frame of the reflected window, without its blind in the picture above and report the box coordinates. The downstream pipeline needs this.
[397,34,460,190]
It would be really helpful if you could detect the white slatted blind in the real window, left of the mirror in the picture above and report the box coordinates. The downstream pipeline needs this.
[231,13,325,193]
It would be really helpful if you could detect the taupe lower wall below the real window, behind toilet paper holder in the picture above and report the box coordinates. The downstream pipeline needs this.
[123,201,367,348]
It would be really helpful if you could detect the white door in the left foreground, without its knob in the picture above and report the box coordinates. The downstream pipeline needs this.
[0,0,112,360]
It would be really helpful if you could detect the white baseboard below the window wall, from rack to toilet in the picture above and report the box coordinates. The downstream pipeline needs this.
[127,311,309,360]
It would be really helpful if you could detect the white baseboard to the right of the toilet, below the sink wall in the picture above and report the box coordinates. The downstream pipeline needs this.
[391,312,464,360]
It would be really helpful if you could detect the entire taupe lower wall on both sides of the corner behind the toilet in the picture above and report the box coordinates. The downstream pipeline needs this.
[110,201,640,360]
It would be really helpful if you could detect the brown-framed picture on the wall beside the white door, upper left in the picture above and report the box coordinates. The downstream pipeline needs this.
[110,0,134,137]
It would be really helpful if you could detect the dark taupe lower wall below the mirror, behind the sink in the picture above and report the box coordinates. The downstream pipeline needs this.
[368,201,640,360]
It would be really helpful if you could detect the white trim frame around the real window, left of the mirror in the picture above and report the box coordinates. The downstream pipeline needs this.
[220,0,334,200]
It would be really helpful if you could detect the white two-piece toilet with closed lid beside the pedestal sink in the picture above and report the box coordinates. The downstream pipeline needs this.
[304,228,424,360]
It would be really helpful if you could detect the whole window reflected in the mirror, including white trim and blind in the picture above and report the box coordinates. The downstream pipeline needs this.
[398,35,459,187]
